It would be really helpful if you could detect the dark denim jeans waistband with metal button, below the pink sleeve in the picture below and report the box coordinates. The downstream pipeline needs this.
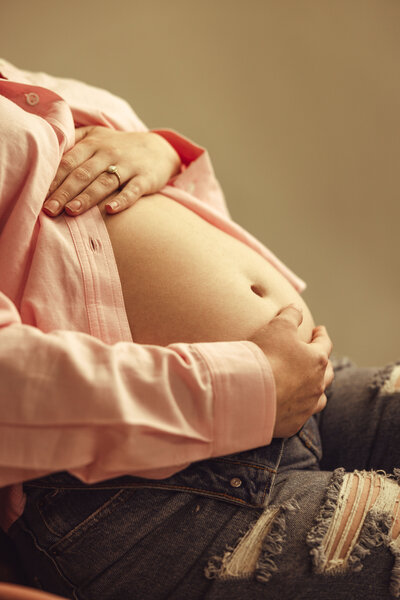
[25,418,321,508]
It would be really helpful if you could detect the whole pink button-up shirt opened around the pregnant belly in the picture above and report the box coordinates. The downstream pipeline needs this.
[0,61,303,528]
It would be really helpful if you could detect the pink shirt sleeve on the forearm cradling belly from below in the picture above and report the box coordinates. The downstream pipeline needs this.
[0,293,275,487]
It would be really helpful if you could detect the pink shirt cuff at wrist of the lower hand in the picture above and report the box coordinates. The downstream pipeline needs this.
[193,341,276,456]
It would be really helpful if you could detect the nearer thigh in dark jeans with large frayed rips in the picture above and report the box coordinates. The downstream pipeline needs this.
[11,469,398,600]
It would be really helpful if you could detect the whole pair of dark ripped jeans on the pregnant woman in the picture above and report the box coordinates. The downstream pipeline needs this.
[9,362,400,600]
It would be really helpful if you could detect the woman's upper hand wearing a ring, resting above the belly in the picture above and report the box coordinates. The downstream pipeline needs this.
[43,126,181,217]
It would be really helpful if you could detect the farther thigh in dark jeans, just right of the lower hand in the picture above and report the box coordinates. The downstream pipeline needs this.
[319,363,400,472]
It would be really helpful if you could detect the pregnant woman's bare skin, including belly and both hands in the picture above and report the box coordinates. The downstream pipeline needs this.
[44,127,333,437]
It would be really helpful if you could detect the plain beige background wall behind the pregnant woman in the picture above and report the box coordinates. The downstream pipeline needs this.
[0,0,400,365]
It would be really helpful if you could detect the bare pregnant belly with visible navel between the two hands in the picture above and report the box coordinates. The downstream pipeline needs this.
[100,194,314,345]
